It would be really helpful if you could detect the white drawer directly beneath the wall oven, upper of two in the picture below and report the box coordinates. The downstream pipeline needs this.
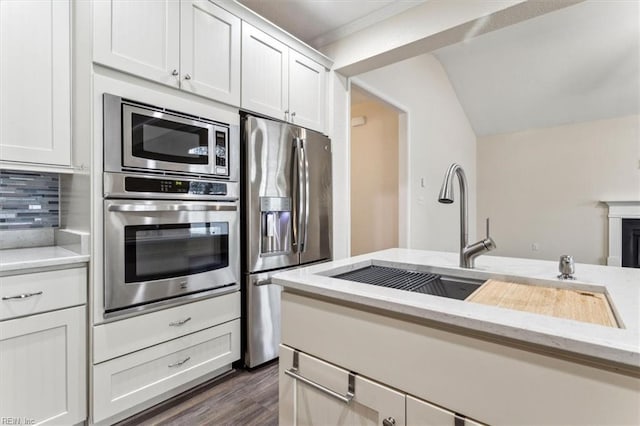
[93,291,240,364]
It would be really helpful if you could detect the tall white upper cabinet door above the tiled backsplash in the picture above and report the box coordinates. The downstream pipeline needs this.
[0,0,71,166]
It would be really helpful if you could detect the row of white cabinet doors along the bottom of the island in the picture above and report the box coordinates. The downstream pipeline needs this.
[279,345,482,426]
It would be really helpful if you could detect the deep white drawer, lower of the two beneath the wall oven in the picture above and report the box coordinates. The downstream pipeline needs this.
[93,319,240,423]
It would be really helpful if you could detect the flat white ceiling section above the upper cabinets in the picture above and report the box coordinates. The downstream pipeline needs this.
[238,0,426,48]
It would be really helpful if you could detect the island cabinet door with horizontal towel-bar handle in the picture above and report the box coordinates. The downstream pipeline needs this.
[279,345,405,426]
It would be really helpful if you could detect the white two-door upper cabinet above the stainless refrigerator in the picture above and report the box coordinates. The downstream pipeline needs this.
[241,22,326,132]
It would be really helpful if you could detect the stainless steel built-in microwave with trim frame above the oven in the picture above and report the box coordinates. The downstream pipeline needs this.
[103,93,239,181]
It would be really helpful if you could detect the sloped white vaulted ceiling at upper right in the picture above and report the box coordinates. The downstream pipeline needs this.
[435,0,640,136]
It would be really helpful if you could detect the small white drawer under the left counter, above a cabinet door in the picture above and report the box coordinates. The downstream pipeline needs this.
[0,267,87,320]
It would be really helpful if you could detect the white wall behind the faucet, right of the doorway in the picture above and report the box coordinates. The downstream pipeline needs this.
[357,54,476,252]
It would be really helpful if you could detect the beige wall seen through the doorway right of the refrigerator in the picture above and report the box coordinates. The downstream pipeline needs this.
[351,101,398,256]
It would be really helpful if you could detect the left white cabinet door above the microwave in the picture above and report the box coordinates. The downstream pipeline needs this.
[93,0,180,87]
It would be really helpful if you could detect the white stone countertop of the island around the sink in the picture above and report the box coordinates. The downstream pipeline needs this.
[273,249,640,371]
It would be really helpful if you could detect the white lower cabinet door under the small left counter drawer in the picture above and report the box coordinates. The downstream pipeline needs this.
[0,307,87,425]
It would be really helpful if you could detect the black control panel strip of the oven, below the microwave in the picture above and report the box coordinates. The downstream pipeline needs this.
[124,176,227,195]
